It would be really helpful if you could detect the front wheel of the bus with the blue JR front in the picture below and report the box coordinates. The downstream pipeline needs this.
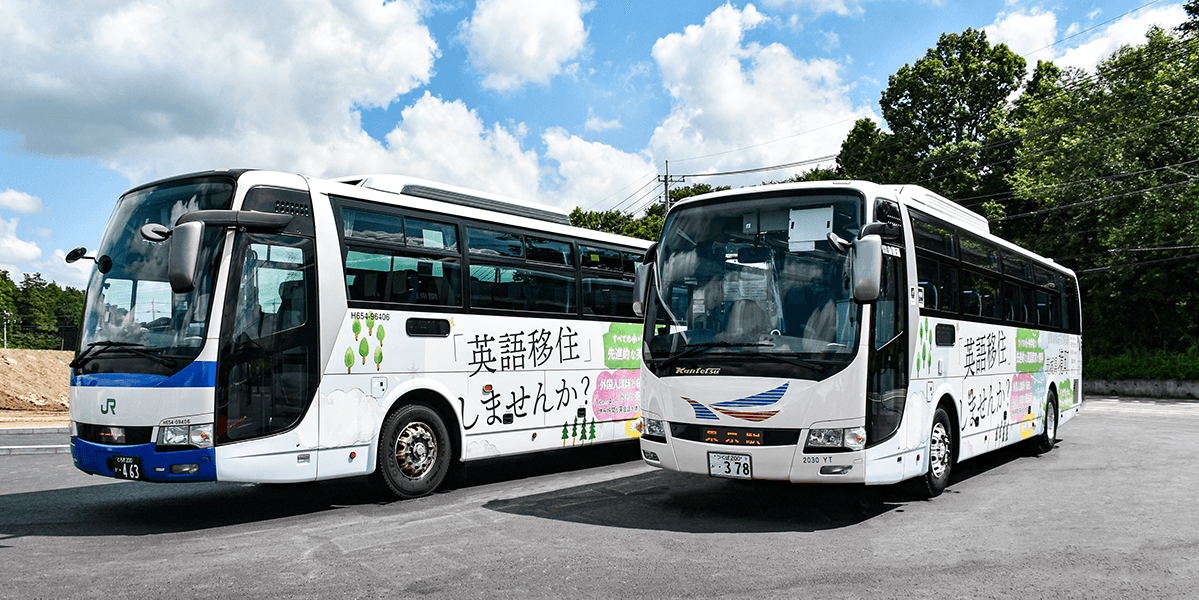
[370,404,452,499]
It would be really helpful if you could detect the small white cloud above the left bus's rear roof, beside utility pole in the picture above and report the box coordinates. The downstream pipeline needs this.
[542,127,656,210]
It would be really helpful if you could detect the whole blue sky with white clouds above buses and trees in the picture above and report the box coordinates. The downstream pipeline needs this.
[0,0,1186,288]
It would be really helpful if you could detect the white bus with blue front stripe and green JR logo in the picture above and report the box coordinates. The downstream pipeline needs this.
[68,170,650,498]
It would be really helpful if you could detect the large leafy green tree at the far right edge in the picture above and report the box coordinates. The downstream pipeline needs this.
[999,29,1199,356]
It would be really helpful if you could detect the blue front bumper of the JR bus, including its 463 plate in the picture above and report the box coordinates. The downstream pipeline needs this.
[71,436,217,482]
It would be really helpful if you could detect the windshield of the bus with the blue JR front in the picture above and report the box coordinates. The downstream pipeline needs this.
[73,178,234,376]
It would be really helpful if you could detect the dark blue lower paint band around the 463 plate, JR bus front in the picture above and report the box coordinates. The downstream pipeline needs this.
[71,437,217,482]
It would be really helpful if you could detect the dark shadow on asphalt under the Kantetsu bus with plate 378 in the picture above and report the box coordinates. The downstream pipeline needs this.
[484,444,1045,533]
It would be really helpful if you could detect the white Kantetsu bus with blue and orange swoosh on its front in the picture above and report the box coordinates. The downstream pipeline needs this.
[635,181,1083,496]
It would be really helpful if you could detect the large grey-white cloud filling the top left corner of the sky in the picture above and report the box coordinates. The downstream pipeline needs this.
[0,0,438,181]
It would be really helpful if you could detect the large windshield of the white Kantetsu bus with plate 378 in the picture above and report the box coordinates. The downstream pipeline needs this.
[645,192,863,379]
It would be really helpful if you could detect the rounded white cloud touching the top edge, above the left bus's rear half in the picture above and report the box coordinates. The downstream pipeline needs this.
[462,0,591,91]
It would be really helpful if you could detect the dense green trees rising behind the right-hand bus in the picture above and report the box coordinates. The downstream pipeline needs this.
[571,5,1199,369]
